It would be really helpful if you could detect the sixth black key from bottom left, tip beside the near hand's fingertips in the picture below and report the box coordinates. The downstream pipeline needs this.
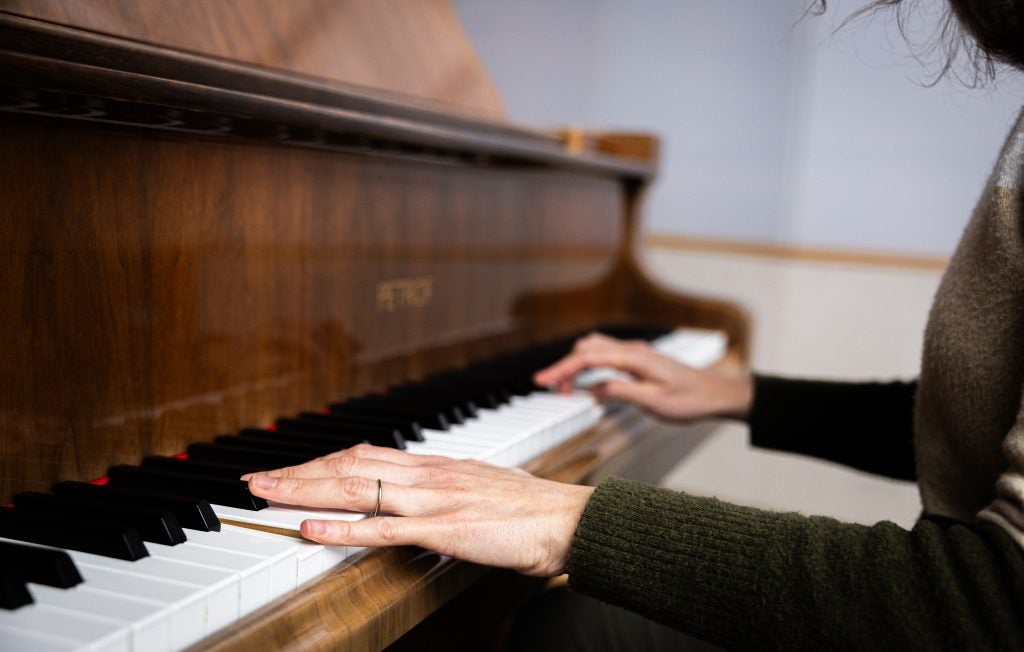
[108,465,267,511]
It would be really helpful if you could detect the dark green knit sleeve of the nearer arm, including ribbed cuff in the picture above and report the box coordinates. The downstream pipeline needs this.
[568,479,1024,650]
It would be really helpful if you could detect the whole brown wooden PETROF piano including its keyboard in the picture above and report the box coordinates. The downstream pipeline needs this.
[0,0,748,650]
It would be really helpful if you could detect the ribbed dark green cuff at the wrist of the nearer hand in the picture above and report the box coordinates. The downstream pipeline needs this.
[567,478,772,646]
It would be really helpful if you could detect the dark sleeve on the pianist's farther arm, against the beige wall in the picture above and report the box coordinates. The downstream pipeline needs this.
[748,376,918,480]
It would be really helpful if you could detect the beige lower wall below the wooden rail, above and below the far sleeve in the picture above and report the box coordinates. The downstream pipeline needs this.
[644,243,941,526]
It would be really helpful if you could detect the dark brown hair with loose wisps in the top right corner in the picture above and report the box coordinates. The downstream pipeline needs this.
[812,0,1024,86]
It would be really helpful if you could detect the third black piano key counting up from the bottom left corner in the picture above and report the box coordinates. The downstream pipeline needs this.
[0,508,150,562]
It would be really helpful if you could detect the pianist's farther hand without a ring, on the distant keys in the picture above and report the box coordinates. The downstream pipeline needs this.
[534,334,754,421]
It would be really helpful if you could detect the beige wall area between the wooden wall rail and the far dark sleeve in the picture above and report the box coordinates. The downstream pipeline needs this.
[644,243,941,378]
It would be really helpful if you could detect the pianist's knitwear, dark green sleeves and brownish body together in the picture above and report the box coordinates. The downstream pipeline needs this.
[568,109,1024,650]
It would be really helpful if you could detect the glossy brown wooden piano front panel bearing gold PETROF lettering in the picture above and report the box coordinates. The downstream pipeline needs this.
[0,113,624,495]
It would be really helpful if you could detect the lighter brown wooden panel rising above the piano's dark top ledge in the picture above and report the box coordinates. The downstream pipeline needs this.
[0,0,504,120]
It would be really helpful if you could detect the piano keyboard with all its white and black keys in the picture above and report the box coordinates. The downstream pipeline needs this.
[0,330,726,652]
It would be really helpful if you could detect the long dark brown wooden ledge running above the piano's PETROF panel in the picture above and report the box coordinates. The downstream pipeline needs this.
[0,12,653,180]
